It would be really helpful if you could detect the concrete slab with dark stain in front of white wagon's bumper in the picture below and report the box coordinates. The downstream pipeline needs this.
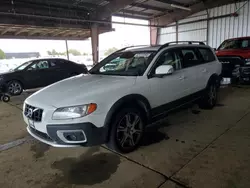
[0,141,164,188]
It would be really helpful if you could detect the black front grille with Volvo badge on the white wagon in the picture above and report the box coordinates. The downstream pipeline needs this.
[24,104,43,122]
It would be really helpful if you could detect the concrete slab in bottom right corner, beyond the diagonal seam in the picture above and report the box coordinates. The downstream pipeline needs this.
[170,111,250,188]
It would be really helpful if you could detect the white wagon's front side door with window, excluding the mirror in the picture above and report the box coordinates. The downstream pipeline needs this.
[149,50,188,115]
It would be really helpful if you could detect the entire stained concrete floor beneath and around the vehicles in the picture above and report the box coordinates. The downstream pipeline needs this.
[0,87,250,188]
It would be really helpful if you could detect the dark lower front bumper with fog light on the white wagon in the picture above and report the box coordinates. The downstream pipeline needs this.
[27,123,107,147]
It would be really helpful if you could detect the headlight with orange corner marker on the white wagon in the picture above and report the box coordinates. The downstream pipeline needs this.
[52,103,97,120]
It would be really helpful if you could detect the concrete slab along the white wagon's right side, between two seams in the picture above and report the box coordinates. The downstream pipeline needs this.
[127,88,250,177]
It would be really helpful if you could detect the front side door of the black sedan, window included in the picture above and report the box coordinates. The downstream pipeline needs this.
[24,60,49,89]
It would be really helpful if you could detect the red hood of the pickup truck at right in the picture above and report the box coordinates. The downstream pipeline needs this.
[216,49,250,59]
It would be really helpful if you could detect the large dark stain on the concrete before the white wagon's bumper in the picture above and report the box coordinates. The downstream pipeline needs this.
[45,147,120,188]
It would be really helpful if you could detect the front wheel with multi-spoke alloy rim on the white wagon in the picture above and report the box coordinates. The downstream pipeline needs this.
[106,108,145,153]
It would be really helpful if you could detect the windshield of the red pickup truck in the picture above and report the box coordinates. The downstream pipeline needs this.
[219,39,250,50]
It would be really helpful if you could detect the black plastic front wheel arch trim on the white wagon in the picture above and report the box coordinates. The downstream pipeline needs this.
[104,94,151,139]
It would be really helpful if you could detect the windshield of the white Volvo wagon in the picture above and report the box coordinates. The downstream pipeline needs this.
[90,51,155,76]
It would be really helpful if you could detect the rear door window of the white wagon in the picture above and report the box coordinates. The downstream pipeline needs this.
[181,48,202,68]
